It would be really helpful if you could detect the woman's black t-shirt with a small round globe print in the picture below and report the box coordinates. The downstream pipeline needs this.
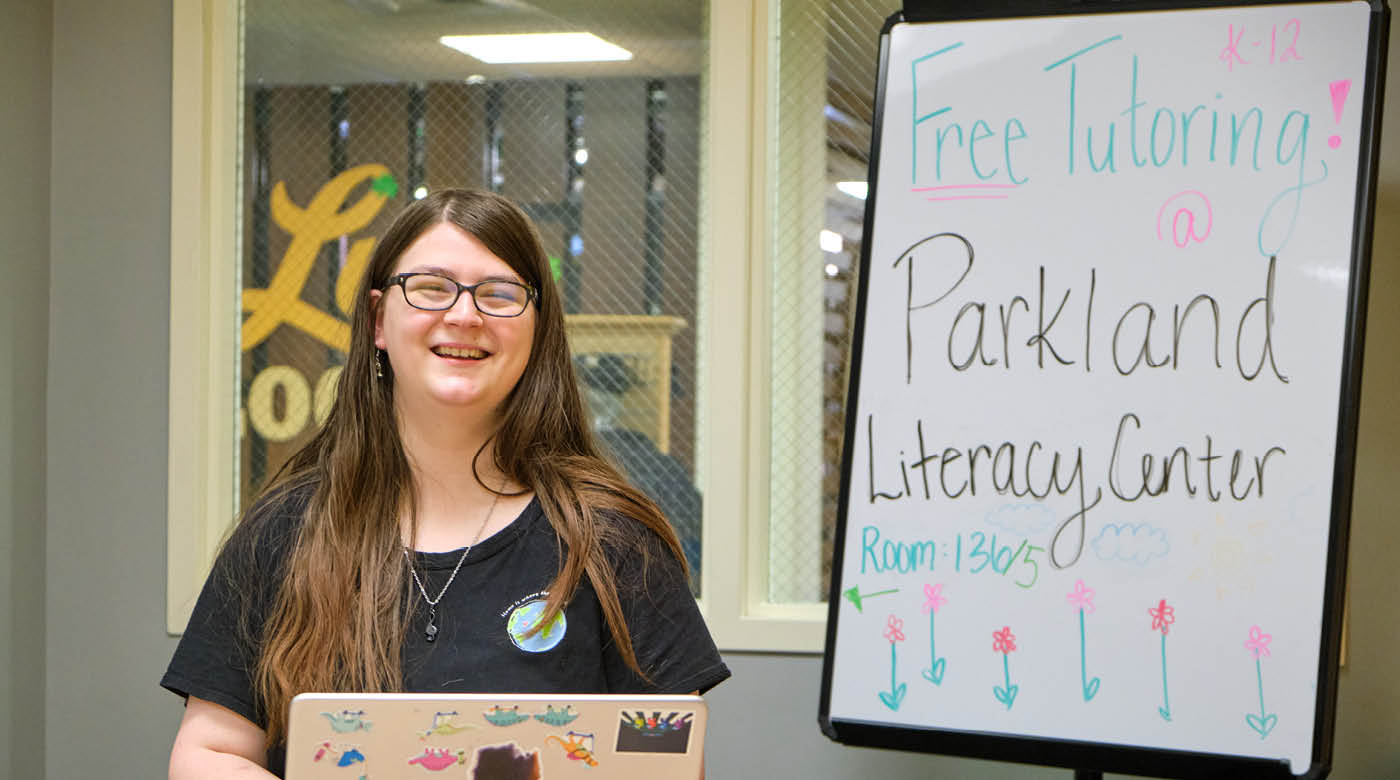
[161,487,729,776]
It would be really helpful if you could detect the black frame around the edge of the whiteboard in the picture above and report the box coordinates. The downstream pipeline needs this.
[818,0,1390,780]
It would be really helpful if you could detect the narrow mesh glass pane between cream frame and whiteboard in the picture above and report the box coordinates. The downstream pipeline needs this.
[766,0,899,604]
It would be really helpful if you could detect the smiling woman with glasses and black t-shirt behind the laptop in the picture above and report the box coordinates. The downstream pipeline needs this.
[161,189,729,777]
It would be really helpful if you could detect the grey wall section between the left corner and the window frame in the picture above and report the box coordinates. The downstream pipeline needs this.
[44,0,177,780]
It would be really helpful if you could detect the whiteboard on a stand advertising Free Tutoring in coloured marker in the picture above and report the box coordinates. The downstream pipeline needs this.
[820,1,1386,774]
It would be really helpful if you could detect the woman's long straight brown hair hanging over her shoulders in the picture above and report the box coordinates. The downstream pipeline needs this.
[235,189,685,745]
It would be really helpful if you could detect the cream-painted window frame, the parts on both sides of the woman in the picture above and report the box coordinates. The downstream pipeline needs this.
[167,0,826,653]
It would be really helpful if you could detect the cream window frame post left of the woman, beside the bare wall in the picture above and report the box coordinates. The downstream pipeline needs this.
[165,0,242,634]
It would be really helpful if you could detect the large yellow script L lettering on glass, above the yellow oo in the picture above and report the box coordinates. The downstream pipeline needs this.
[242,164,398,351]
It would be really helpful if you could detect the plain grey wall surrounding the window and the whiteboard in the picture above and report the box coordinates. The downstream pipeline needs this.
[0,0,1400,780]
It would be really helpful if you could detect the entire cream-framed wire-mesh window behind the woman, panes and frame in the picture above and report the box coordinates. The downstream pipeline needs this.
[168,0,883,650]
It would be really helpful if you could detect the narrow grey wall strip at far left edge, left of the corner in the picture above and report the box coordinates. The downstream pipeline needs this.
[0,0,52,779]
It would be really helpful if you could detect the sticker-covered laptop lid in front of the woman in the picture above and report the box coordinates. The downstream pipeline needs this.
[286,693,707,780]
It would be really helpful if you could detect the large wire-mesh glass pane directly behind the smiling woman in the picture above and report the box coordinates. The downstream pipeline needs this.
[237,0,706,587]
